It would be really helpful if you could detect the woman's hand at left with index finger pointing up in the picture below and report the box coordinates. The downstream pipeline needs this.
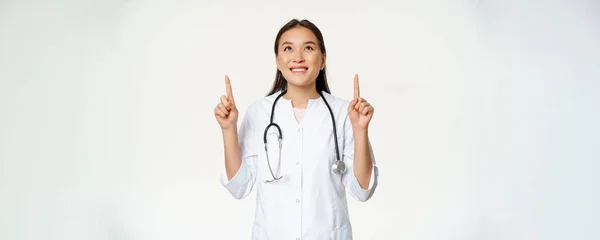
[215,75,238,130]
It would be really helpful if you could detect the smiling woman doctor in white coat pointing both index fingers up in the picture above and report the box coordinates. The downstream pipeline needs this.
[214,19,378,240]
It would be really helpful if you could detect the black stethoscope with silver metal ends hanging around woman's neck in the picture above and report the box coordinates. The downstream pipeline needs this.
[263,90,346,183]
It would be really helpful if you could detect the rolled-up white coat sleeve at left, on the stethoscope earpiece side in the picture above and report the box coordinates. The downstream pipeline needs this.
[220,108,258,199]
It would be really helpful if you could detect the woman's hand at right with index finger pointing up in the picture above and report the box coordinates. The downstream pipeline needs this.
[348,75,375,132]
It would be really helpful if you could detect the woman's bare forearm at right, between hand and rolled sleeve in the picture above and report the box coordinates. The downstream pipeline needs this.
[353,129,373,189]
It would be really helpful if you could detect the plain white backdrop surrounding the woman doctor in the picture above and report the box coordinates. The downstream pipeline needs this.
[0,0,600,240]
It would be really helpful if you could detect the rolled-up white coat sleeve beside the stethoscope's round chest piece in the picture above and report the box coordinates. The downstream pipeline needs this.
[342,111,379,202]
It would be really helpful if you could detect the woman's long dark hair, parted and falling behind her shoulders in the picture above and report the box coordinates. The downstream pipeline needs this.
[267,19,331,96]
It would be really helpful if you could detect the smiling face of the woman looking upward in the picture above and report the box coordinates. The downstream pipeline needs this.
[276,27,325,86]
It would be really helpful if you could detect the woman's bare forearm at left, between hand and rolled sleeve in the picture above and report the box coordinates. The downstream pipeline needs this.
[222,127,242,180]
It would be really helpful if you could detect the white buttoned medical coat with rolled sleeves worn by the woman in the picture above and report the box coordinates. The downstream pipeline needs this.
[220,92,379,240]
